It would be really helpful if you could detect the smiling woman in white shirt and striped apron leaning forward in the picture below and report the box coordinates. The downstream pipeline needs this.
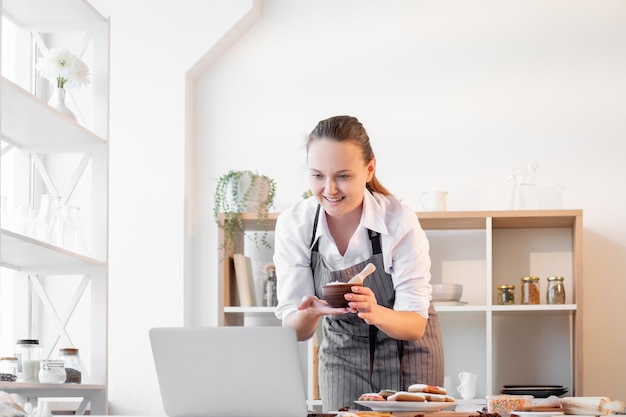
[274,116,443,411]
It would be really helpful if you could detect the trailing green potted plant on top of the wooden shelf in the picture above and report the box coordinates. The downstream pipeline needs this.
[213,170,276,253]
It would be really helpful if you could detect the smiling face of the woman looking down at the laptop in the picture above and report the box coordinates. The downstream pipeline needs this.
[308,139,376,217]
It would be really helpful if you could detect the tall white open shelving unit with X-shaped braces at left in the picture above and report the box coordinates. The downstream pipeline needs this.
[0,0,109,414]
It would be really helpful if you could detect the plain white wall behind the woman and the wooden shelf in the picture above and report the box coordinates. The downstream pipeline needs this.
[93,0,626,414]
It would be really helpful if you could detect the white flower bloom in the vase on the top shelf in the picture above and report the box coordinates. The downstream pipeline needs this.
[37,48,89,88]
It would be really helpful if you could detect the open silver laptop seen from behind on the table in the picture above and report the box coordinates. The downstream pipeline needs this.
[149,326,308,417]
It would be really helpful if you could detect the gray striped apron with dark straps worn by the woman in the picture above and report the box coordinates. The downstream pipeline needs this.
[311,205,443,412]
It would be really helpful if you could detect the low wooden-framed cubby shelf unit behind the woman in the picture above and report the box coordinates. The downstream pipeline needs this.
[218,210,582,403]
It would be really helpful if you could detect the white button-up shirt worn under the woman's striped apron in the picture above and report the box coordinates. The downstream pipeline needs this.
[274,191,432,319]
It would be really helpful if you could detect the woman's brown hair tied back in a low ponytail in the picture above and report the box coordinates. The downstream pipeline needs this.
[306,116,391,195]
